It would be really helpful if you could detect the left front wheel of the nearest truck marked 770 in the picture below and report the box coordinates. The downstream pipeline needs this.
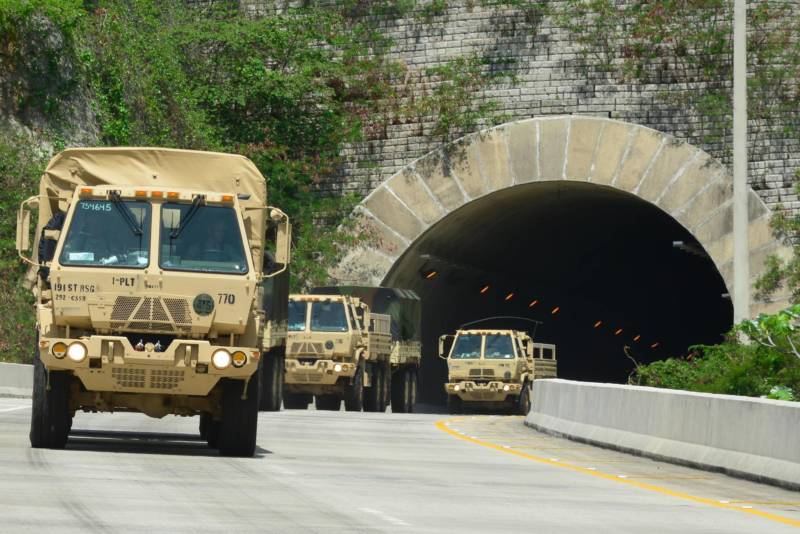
[30,350,72,449]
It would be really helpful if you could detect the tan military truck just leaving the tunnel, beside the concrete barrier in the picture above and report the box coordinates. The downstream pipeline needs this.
[439,329,556,415]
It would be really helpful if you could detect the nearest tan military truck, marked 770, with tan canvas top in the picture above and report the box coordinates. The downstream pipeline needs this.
[17,148,291,456]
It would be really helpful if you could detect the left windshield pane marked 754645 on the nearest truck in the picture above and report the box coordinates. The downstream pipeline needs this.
[58,200,150,269]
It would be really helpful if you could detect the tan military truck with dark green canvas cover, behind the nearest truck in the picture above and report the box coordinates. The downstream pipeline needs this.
[284,286,421,413]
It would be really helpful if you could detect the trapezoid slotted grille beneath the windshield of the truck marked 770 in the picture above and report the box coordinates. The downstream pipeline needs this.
[111,297,192,332]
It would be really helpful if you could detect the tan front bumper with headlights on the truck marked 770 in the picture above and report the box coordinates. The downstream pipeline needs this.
[39,335,260,396]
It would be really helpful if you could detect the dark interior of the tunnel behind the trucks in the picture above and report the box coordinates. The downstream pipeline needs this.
[383,181,733,404]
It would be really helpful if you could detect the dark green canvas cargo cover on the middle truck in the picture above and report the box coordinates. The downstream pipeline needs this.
[309,286,422,341]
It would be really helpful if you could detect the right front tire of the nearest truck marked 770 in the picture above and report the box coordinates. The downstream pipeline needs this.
[219,372,260,456]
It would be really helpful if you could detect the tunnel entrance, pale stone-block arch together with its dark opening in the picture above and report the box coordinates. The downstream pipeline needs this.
[331,116,787,401]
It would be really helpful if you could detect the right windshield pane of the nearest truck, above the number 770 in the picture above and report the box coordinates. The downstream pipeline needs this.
[159,202,247,274]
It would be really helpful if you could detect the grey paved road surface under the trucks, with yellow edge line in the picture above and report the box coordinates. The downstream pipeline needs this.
[0,398,800,534]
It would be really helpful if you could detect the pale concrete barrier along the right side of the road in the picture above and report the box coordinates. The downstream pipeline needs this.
[525,380,800,490]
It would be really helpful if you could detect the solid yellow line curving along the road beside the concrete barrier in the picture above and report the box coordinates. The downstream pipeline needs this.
[436,417,800,527]
